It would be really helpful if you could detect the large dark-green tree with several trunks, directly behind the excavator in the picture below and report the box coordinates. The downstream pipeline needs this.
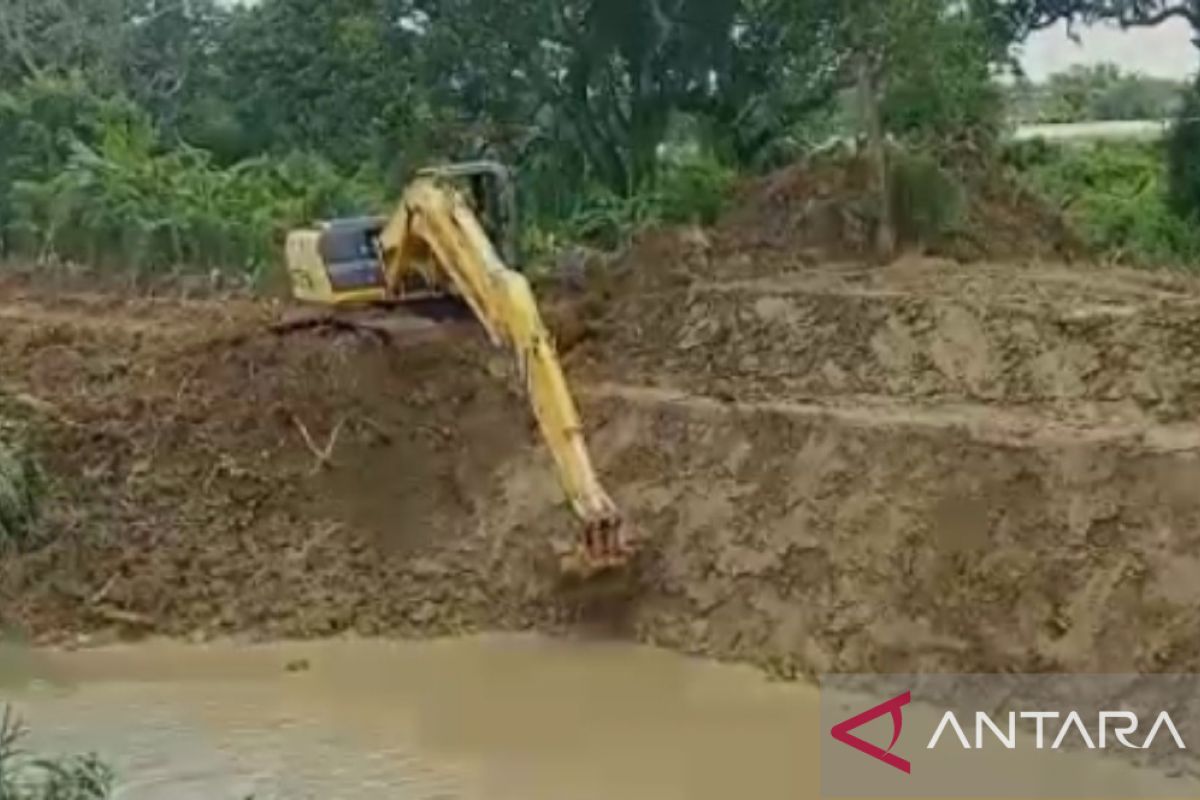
[421,0,836,194]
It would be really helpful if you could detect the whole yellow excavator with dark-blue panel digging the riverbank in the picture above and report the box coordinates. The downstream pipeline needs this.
[287,162,632,577]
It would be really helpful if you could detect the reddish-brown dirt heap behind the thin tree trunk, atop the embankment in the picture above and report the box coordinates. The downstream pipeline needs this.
[626,156,1086,284]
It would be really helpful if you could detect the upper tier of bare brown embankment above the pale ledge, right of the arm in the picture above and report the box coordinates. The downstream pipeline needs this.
[589,259,1200,423]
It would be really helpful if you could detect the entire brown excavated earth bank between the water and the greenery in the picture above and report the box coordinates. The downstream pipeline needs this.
[0,247,1200,675]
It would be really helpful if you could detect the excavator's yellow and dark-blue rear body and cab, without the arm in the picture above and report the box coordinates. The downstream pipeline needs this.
[287,161,520,306]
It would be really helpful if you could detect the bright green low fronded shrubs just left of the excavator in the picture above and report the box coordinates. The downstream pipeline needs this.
[13,117,376,277]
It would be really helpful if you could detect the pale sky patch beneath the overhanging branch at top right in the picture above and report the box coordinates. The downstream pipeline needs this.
[1021,19,1200,80]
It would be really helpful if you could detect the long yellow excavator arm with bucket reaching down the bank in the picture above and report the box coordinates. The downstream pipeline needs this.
[378,178,630,575]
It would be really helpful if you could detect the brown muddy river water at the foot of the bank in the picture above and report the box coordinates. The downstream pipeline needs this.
[0,636,1195,800]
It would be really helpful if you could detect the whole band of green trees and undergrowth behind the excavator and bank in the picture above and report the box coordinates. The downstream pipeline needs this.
[0,0,1182,277]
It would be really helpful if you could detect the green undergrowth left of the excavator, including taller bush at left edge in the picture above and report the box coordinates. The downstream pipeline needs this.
[0,76,373,273]
